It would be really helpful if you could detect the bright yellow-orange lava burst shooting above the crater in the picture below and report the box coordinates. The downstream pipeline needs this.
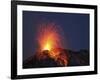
[37,23,63,50]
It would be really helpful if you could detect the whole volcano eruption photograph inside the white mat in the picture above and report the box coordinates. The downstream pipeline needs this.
[22,10,90,69]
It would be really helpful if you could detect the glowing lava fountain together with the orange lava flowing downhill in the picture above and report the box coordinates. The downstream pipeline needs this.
[37,23,68,66]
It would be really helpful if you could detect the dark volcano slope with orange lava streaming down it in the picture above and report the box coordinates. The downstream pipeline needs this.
[23,49,89,68]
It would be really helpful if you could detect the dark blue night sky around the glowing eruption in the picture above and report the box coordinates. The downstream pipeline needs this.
[23,11,89,59]
